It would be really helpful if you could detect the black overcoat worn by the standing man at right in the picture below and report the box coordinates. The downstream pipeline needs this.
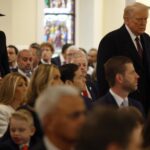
[97,25,150,110]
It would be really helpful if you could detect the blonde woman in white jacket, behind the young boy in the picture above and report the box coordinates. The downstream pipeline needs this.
[0,72,28,137]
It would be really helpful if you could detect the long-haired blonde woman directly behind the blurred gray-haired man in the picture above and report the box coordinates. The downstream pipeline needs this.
[27,64,62,106]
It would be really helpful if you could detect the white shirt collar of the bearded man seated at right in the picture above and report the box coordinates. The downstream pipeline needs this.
[109,89,128,107]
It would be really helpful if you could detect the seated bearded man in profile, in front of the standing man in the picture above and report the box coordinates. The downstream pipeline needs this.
[96,56,144,114]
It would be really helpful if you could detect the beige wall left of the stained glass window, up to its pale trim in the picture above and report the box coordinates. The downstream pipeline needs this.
[0,0,37,48]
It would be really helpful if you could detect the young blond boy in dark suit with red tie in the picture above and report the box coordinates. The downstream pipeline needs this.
[0,109,36,150]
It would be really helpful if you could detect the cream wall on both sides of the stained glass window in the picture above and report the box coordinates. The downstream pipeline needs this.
[0,0,150,50]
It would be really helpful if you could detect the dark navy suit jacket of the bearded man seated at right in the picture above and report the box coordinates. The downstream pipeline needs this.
[94,92,145,116]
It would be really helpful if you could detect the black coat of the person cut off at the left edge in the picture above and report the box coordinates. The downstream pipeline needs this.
[0,31,10,77]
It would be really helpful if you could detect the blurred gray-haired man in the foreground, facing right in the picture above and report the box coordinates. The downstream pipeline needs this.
[33,85,85,150]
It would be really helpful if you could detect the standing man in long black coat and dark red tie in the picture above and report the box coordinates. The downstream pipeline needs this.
[97,2,150,111]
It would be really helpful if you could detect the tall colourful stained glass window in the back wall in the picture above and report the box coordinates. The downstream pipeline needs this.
[43,0,75,51]
